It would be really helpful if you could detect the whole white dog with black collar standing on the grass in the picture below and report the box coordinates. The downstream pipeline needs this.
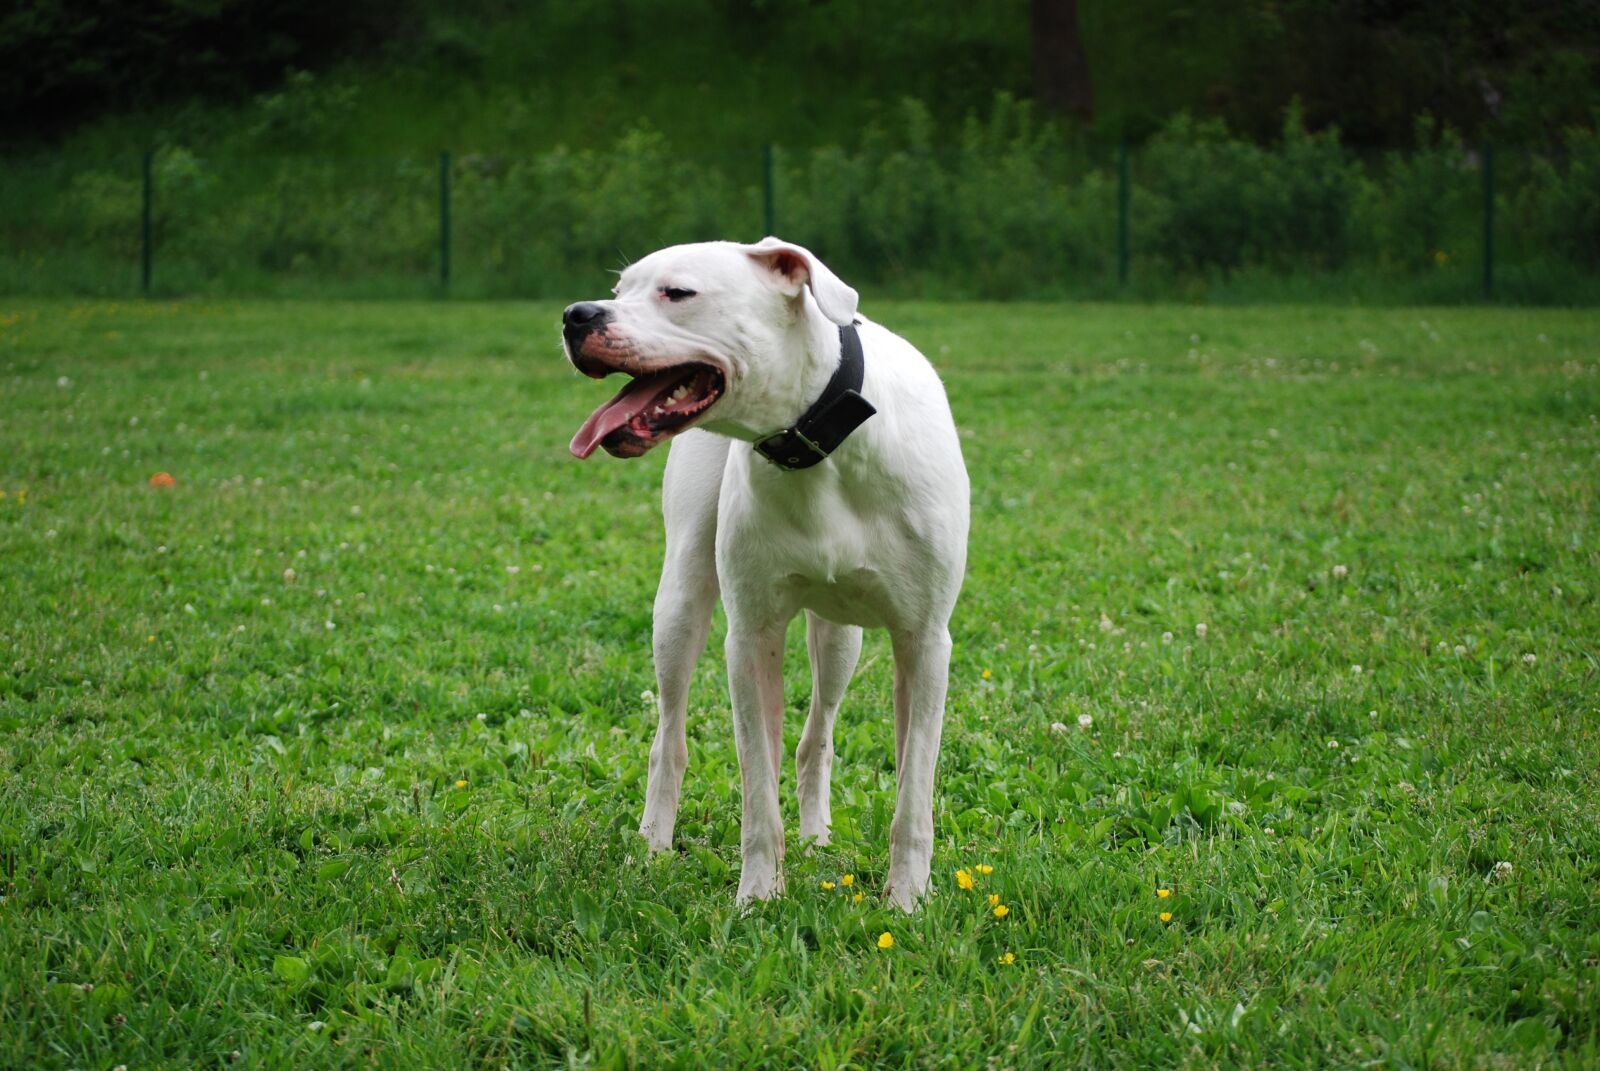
[563,239,968,911]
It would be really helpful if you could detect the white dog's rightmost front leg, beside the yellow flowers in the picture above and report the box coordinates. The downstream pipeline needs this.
[883,626,950,911]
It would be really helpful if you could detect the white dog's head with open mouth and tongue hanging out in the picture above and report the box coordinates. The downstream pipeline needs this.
[562,239,856,458]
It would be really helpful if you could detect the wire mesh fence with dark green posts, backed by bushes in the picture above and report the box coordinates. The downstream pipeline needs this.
[0,130,1600,301]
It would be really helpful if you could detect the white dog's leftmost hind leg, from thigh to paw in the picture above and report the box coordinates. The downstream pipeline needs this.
[638,431,728,852]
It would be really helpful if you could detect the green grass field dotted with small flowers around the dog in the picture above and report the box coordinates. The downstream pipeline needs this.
[0,299,1600,1071]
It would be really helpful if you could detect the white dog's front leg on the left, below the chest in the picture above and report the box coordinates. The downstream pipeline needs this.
[726,620,784,903]
